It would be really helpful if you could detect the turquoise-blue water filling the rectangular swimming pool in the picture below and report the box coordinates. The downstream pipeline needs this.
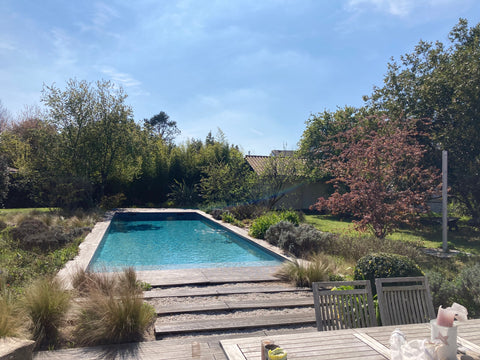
[89,213,282,271]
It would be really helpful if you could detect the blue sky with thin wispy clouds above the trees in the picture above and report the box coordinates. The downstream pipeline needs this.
[0,0,480,155]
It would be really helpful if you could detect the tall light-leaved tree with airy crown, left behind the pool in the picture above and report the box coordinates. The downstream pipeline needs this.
[42,79,139,199]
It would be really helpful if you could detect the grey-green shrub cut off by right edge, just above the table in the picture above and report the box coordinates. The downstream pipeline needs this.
[455,263,480,318]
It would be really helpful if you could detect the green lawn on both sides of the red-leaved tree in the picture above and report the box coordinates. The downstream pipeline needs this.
[305,215,480,255]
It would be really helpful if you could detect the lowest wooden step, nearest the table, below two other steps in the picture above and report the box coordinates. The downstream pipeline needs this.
[155,309,315,336]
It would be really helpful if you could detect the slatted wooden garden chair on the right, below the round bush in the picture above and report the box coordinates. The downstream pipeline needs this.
[375,276,435,325]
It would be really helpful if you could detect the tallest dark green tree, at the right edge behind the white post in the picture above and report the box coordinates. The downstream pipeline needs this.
[365,19,480,223]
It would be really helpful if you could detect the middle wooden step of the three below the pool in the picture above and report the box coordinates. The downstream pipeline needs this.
[155,297,313,315]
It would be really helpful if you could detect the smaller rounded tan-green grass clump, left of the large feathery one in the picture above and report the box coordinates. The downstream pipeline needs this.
[22,277,70,346]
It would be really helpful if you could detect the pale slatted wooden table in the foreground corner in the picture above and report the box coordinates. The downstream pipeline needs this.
[220,319,480,360]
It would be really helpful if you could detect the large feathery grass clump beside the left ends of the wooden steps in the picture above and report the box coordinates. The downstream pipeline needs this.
[75,268,156,345]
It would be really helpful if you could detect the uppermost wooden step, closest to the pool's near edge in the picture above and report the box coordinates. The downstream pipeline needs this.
[143,286,312,299]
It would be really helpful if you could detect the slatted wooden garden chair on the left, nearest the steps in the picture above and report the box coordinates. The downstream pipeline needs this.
[312,280,377,331]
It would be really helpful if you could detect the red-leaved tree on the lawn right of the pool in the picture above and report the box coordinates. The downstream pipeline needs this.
[313,117,439,238]
